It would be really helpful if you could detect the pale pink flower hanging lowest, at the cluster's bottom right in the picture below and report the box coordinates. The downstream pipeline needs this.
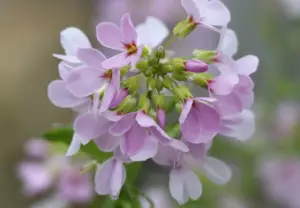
[153,144,231,205]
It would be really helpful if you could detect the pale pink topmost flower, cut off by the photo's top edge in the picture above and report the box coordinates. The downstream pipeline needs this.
[181,0,231,32]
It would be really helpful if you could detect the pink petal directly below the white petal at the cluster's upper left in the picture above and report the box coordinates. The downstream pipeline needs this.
[77,48,106,69]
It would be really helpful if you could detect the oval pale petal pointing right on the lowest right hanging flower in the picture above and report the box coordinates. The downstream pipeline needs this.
[203,157,232,185]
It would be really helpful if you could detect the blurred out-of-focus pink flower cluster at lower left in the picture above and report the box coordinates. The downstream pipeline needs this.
[17,139,94,207]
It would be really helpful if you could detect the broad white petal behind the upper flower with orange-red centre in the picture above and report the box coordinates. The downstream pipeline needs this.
[136,17,169,48]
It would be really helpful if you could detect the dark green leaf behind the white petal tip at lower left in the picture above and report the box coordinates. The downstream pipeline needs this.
[43,127,112,162]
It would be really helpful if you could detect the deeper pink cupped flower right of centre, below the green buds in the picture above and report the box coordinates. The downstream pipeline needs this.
[179,98,221,144]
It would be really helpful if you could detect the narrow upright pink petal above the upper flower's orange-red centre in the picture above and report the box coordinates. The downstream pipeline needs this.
[121,13,137,43]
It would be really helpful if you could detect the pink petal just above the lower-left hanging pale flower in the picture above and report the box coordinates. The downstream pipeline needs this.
[95,133,122,152]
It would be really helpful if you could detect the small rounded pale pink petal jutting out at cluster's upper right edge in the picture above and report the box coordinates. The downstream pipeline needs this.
[235,55,259,76]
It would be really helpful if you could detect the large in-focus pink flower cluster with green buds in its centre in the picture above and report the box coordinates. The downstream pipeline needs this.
[48,0,258,204]
